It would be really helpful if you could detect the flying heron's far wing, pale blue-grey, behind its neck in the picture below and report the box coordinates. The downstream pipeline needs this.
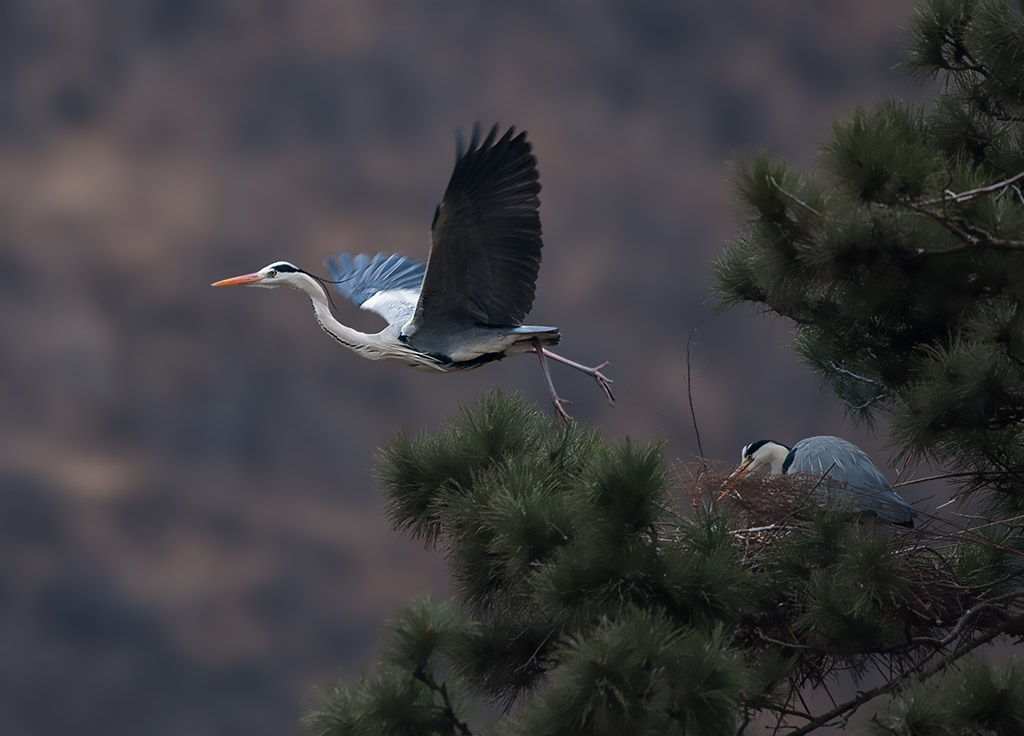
[324,253,426,324]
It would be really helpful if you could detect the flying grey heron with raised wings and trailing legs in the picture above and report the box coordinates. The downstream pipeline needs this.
[213,125,615,421]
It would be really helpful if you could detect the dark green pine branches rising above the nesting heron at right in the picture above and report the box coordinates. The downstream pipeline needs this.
[715,0,1024,516]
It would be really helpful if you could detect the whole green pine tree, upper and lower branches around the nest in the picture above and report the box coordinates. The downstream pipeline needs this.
[306,0,1024,736]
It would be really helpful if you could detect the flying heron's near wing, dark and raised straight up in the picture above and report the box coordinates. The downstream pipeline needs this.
[409,125,543,332]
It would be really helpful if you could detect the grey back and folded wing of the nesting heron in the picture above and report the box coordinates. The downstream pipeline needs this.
[782,436,915,526]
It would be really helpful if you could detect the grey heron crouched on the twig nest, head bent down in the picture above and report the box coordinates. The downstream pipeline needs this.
[720,437,916,526]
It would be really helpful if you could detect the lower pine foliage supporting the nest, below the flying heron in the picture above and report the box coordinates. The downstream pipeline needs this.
[306,393,1024,736]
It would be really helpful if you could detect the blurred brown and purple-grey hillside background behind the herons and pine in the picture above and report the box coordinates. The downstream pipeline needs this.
[0,0,928,736]
